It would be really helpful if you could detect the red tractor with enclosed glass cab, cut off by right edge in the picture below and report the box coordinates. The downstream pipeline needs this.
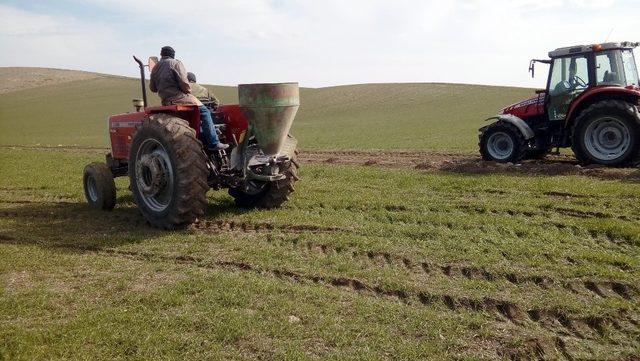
[480,42,640,166]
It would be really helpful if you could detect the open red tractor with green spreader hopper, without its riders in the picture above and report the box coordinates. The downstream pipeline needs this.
[84,57,299,229]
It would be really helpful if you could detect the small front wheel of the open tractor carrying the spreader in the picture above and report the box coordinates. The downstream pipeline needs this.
[82,162,116,211]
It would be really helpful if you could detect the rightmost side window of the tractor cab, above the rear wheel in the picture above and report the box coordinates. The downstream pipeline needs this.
[596,50,638,86]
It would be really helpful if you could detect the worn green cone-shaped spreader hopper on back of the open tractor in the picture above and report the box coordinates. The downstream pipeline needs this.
[238,83,300,156]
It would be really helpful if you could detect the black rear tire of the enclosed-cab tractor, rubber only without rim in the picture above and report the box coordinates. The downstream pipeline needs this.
[571,100,640,167]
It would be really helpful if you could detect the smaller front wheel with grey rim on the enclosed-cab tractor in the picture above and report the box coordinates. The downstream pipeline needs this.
[479,121,526,163]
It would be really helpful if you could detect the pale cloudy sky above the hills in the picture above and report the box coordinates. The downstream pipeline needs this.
[0,0,640,87]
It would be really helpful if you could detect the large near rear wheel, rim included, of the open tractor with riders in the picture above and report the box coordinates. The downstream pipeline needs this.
[129,114,209,229]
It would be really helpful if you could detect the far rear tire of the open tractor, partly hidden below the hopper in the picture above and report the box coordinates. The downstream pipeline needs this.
[229,157,299,209]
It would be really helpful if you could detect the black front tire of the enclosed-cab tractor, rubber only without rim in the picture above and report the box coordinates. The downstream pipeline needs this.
[478,121,527,163]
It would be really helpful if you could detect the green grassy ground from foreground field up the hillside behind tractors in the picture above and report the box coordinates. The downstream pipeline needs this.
[0,69,640,360]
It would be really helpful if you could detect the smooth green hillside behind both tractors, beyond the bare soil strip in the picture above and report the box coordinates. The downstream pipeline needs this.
[0,68,531,152]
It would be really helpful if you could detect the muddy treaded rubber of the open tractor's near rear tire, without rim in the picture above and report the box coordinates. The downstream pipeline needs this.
[129,114,209,229]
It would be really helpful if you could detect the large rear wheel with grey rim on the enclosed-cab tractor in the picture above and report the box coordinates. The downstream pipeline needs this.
[571,100,640,167]
